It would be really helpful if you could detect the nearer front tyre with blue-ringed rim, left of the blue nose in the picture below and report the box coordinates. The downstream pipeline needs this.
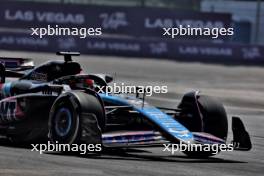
[48,91,105,144]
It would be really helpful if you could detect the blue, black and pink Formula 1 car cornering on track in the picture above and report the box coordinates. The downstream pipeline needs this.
[0,52,251,157]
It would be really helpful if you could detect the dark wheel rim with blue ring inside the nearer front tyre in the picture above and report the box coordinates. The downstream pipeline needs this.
[55,107,72,137]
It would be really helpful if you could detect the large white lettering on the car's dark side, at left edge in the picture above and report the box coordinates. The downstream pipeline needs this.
[0,101,16,122]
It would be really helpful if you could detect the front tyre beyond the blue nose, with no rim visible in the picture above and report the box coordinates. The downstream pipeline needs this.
[177,92,228,139]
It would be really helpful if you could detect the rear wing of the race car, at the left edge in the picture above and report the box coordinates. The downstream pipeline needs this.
[0,57,34,71]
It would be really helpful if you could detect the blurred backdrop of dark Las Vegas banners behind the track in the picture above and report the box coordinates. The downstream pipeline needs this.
[0,0,264,64]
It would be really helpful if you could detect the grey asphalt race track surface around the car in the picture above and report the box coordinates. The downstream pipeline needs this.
[0,51,264,176]
